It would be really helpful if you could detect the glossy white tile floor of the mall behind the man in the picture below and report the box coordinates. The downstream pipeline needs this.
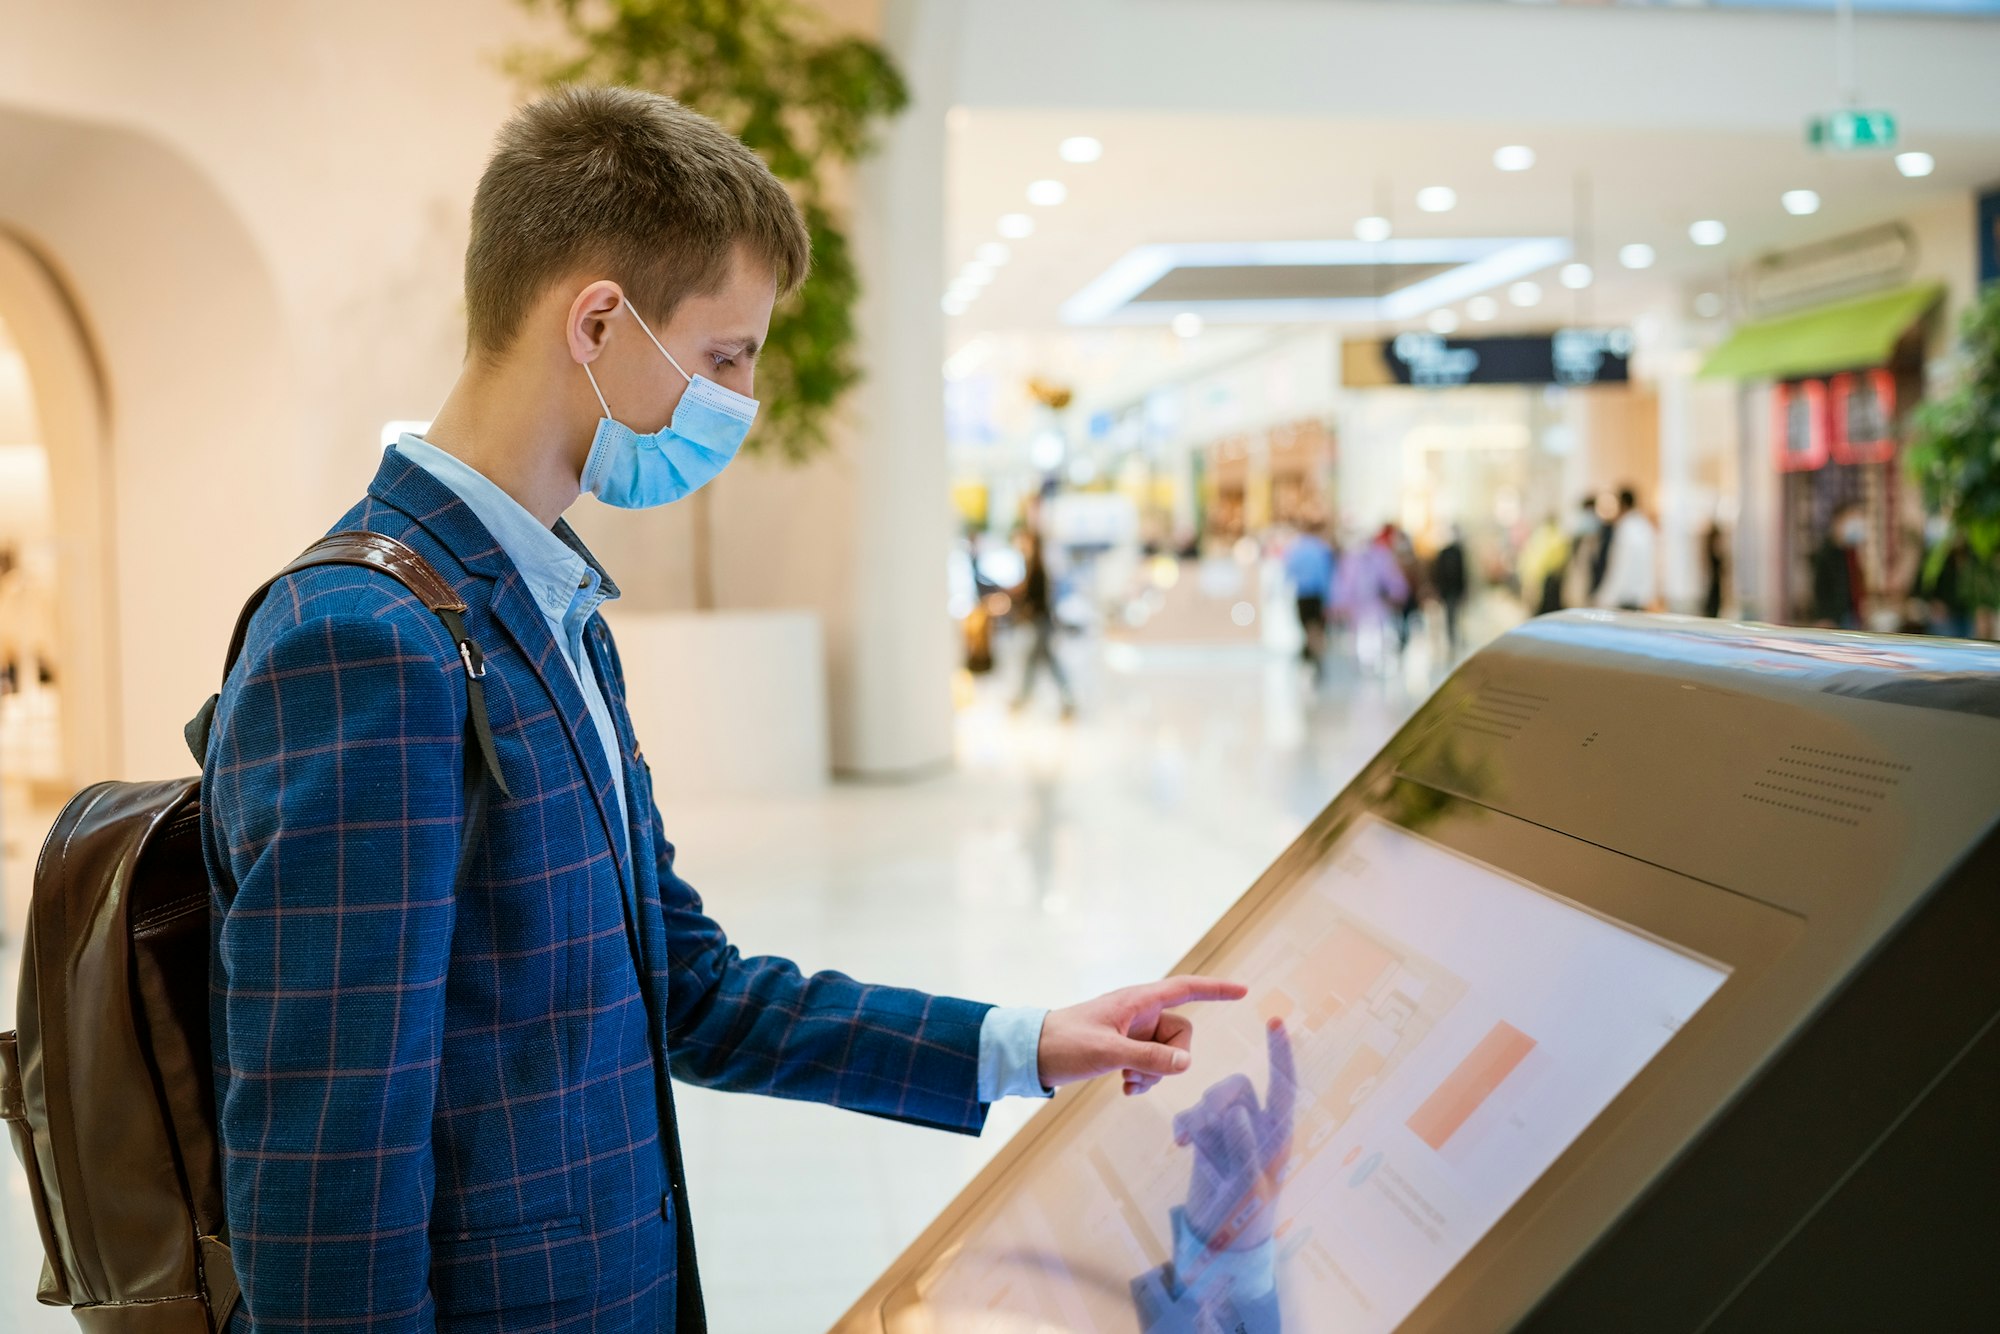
[0,602,1512,1334]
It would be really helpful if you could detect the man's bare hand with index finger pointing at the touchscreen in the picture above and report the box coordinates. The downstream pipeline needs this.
[1038,976,1248,1096]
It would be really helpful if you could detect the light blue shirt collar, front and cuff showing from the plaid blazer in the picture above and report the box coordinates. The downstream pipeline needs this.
[382,434,1050,1102]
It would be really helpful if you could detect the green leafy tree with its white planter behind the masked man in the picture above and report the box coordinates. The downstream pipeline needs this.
[510,0,908,794]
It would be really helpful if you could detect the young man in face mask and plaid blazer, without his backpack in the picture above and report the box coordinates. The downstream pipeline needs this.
[202,88,1242,1334]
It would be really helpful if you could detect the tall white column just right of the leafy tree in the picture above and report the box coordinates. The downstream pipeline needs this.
[832,0,962,778]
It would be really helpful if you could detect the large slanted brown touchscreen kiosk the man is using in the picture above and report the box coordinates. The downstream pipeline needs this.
[836,612,2000,1334]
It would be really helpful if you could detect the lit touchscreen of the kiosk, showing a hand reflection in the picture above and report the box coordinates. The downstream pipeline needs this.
[892,818,1726,1334]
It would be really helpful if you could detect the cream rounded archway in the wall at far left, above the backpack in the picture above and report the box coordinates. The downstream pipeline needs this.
[0,106,296,784]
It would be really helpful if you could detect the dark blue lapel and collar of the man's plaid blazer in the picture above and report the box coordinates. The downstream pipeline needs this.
[368,450,630,876]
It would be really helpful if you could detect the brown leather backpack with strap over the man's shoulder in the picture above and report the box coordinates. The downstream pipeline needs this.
[0,532,506,1334]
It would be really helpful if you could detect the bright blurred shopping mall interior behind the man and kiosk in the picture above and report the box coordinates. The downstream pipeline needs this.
[0,0,2000,1334]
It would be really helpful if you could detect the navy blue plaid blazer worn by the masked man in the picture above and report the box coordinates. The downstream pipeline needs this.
[202,450,988,1334]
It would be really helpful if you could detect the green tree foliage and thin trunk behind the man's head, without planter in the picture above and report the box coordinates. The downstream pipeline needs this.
[512,0,910,610]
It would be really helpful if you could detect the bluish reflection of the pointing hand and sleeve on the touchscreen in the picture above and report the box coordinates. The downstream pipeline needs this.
[1132,1020,1298,1334]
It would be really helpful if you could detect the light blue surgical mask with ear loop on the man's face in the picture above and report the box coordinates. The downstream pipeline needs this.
[584,304,756,510]
